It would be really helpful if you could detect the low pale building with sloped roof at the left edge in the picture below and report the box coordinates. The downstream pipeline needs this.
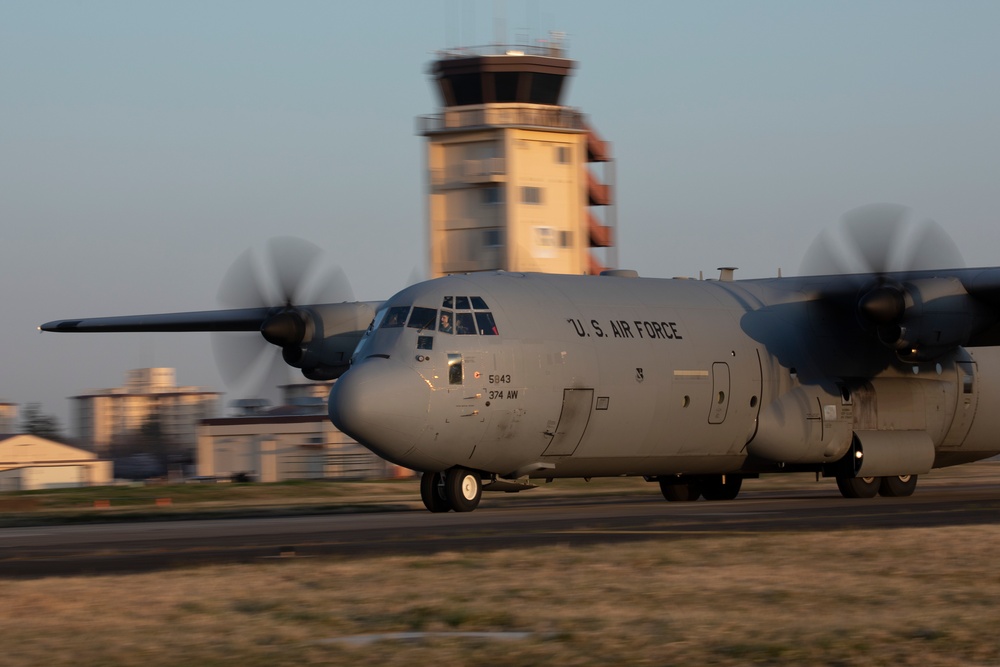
[0,434,113,491]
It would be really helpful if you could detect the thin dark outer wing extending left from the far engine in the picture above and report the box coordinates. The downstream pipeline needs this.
[39,307,281,333]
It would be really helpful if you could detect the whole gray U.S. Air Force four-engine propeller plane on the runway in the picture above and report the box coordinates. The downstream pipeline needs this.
[41,205,1000,512]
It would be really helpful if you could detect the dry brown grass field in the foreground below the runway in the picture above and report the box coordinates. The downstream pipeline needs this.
[0,526,1000,667]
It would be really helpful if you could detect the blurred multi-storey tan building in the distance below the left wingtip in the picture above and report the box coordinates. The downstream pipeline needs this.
[72,368,221,455]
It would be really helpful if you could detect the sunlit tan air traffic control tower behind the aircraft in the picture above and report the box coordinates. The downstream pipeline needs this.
[418,41,617,278]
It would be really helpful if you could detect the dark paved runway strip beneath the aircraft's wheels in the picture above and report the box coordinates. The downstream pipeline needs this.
[0,485,1000,577]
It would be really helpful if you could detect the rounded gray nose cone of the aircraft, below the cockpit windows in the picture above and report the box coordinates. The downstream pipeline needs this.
[329,357,431,465]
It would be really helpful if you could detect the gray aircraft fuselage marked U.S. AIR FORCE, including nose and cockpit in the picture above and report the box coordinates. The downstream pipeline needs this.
[330,273,1000,486]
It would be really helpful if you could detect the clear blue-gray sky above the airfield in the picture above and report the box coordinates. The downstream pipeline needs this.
[0,0,1000,427]
